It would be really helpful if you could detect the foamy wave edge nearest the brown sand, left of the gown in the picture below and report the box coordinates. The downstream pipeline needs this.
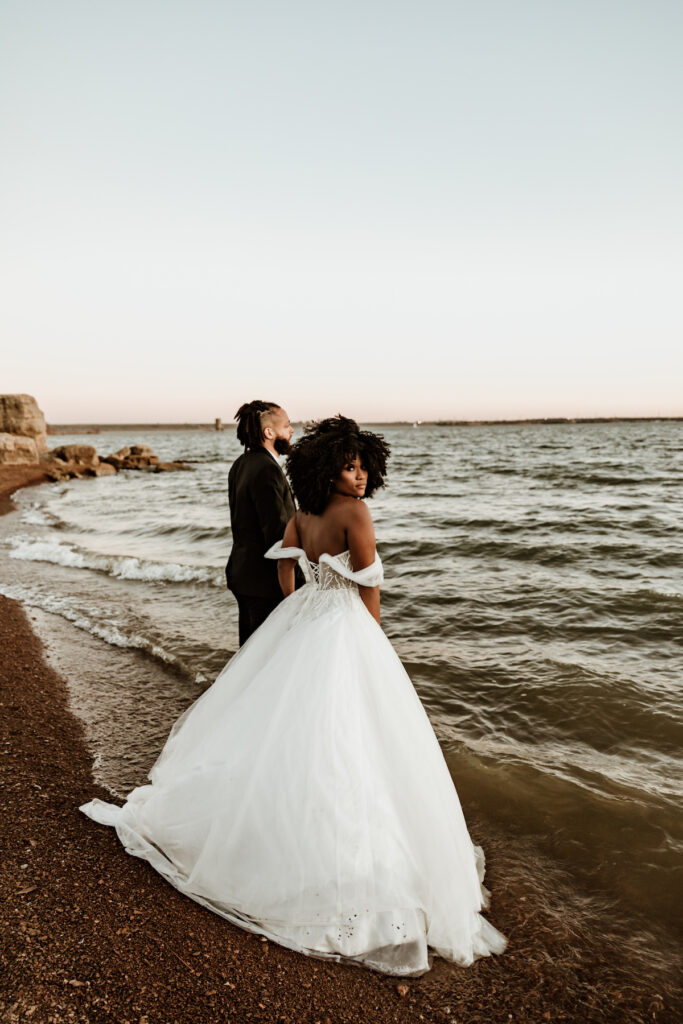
[0,584,206,683]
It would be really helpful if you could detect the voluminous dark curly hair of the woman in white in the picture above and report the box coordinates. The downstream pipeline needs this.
[287,415,390,515]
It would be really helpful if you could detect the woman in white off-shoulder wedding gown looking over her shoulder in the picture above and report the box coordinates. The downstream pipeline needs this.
[81,416,506,975]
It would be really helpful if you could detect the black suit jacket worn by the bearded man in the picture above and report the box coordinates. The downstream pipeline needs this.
[225,447,295,598]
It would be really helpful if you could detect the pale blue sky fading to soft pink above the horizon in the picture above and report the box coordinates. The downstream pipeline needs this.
[0,0,683,423]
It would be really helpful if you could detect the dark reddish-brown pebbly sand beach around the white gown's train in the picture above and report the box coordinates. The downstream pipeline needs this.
[0,470,681,1024]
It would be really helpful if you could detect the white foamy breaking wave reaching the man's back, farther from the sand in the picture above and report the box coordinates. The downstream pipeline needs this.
[7,537,225,587]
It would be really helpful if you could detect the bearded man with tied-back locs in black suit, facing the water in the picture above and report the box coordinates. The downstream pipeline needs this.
[225,401,295,646]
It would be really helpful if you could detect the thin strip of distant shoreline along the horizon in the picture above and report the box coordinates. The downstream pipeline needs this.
[47,416,683,436]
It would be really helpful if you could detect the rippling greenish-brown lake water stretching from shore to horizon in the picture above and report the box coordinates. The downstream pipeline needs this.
[0,423,683,995]
